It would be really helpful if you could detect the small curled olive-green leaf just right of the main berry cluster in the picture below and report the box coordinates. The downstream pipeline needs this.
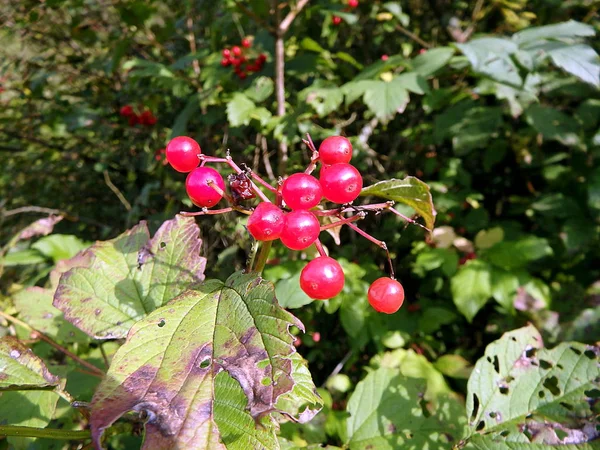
[360,177,437,230]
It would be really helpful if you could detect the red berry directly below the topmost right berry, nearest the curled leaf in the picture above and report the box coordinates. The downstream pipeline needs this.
[320,163,362,203]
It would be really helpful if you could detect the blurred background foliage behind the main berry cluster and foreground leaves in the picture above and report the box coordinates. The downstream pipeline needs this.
[0,0,600,442]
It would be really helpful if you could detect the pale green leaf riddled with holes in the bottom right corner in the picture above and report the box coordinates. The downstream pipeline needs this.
[467,325,600,449]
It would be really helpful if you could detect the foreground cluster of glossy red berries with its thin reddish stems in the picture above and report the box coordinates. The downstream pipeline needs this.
[166,136,404,314]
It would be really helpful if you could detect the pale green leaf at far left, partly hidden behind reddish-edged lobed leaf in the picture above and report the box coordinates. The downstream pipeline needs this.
[12,286,89,343]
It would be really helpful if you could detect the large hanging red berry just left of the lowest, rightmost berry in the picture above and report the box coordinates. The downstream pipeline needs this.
[300,256,344,300]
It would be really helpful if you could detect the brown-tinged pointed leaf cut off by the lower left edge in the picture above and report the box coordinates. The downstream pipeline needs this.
[0,336,60,391]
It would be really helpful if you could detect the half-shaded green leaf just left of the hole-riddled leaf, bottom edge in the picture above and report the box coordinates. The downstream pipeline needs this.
[347,368,466,450]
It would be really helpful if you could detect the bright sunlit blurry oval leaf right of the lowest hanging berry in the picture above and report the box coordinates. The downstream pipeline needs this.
[450,259,492,322]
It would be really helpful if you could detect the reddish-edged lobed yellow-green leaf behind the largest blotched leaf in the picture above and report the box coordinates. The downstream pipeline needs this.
[54,216,206,339]
